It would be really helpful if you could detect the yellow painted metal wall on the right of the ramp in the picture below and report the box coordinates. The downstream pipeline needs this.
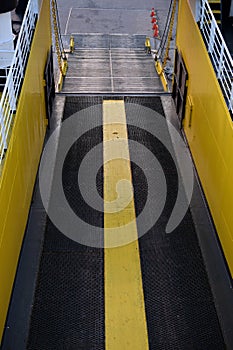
[177,0,233,276]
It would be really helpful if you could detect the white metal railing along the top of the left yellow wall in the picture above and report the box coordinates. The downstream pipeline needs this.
[0,0,38,165]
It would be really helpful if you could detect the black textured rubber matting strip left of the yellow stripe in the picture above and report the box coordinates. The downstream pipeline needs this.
[27,97,105,350]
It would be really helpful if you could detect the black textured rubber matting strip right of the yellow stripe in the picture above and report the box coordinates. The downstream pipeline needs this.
[127,98,225,350]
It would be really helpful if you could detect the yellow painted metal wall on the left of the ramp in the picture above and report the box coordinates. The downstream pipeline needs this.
[0,0,51,340]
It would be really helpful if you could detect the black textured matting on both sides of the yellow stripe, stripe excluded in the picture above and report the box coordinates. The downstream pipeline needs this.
[27,97,225,350]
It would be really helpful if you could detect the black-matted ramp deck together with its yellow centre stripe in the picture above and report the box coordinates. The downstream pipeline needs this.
[25,96,225,350]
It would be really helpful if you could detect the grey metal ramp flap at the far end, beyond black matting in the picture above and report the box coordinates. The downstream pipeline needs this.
[62,34,163,94]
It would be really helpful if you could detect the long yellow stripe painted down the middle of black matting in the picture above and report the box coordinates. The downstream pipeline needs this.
[103,101,149,350]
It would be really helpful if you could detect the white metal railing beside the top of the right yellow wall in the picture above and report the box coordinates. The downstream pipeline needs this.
[198,0,233,113]
